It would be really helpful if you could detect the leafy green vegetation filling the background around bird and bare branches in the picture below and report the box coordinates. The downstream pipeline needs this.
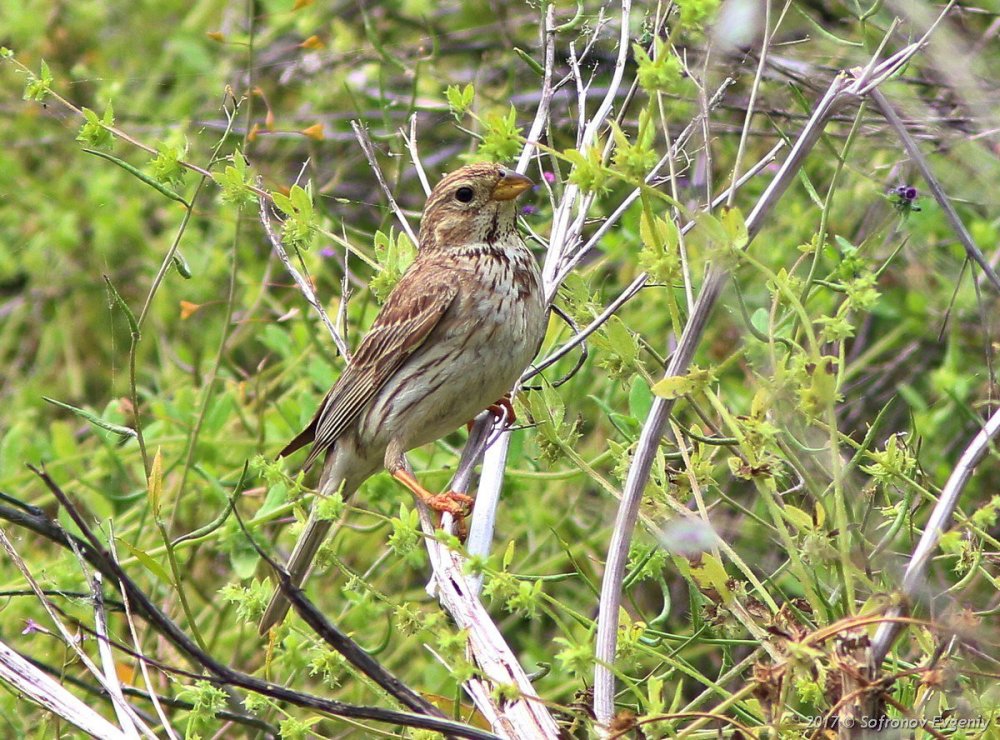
[0,0,1000,738]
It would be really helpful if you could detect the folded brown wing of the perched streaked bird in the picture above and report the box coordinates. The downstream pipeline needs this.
[279,268,458,467]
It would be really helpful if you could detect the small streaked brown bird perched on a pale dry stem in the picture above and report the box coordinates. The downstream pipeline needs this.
[260,164,547,634]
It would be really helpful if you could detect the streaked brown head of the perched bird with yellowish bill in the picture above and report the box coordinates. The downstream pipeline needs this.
[420,162,534,252]
